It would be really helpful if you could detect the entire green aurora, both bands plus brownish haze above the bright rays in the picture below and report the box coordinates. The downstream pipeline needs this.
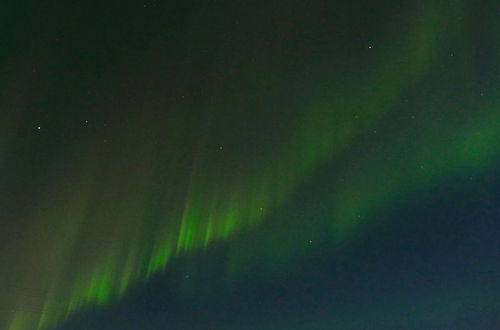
[0,1,500,330]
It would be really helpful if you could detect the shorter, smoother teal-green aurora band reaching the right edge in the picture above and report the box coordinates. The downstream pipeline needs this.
[332,105,500,237]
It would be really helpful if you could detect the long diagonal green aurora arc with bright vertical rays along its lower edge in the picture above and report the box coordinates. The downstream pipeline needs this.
[44,3,468,328]
